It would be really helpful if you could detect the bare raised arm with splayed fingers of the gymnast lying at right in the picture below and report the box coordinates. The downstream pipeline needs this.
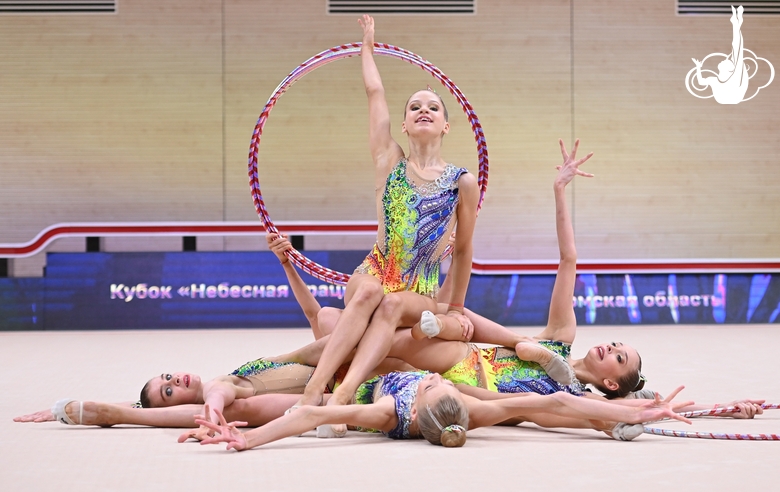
[537,139,593,343]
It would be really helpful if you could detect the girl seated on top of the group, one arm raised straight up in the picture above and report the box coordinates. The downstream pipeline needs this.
[296,15,479,416]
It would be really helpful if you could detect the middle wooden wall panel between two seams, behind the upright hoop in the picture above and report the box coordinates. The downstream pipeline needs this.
[221,0,571,257]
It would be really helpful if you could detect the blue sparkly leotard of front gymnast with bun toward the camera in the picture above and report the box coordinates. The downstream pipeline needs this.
[355,371,429,439]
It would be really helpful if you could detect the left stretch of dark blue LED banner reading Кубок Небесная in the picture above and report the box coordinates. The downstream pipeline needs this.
[0,251,365,330]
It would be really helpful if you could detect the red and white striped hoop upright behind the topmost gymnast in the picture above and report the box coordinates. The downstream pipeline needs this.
[249,43,488,285]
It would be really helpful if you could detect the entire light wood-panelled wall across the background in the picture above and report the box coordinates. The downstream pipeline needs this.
[0,0,780,274]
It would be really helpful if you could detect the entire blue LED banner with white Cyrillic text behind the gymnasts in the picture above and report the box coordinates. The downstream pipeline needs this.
[0,251,780,330]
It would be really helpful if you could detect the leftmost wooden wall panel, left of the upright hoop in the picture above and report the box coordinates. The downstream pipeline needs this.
[0,1,223,242]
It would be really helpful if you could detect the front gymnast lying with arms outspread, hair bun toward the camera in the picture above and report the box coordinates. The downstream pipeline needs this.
[196,372,691,451]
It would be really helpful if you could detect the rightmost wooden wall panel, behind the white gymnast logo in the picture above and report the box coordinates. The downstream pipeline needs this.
[573,0,780,258]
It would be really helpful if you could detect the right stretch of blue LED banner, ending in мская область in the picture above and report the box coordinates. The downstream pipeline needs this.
[466,273,780,326]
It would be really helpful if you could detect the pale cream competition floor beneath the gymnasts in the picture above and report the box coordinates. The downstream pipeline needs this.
[0,325,780,492]
